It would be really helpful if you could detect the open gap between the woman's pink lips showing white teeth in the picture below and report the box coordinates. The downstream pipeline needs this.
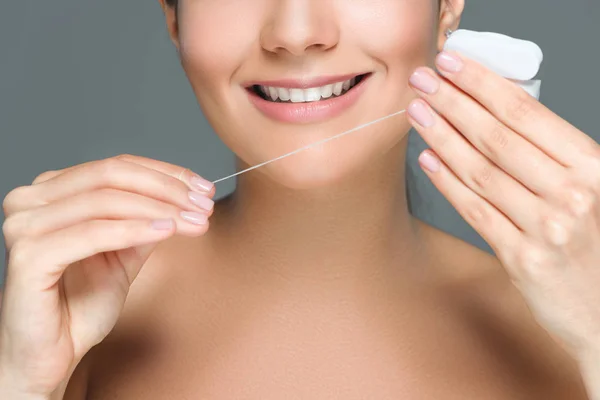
[248,74,370,103]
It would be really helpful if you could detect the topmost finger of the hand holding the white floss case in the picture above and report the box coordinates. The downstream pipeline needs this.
[436,52,598,167]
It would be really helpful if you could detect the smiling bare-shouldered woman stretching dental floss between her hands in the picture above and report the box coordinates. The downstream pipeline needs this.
[0,0,600,400]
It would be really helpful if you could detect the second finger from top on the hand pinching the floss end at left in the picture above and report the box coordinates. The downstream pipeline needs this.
[5,158,214,215]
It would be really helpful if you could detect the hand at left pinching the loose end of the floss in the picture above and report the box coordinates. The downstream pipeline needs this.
[0,155,214,396]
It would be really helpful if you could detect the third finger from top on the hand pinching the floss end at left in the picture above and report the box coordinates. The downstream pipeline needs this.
[4,189,213,249]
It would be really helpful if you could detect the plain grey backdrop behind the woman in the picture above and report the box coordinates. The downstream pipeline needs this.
[0,0,600,280]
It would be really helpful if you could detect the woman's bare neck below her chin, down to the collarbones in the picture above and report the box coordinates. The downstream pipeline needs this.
[209,137,423,279]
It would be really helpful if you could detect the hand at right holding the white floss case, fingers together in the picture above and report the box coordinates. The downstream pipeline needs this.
[408,52,600,361]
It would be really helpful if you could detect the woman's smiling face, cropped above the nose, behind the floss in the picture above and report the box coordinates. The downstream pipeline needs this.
[162,0,458,188]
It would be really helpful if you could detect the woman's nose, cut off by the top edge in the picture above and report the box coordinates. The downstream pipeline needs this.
[261,0,340,56]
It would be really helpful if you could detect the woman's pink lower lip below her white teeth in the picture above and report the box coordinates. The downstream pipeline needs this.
[246,75,371,124]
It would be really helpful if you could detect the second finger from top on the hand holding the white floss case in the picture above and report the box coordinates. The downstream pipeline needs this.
[411,68,567,197]
